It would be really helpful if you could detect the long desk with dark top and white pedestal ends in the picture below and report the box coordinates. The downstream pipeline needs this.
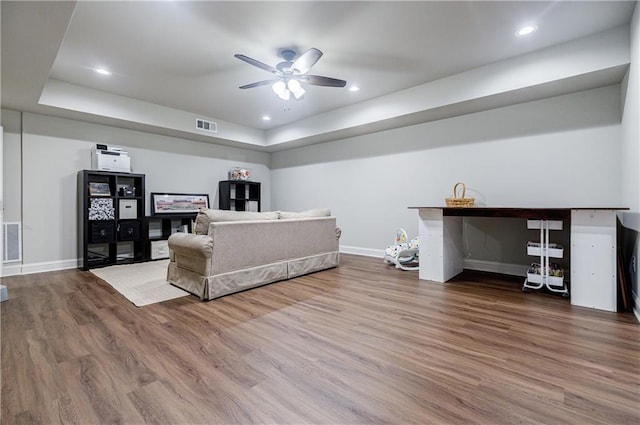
[409,207,628,311]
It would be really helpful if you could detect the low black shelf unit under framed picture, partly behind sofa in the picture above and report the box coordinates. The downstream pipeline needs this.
[145,214,197,260]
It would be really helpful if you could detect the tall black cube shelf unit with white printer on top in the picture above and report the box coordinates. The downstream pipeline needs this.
[78,170,146,270]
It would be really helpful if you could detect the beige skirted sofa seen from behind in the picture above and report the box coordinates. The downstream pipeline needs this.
[167,209,340,300]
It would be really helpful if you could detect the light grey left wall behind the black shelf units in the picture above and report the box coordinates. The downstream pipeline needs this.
[11,113,271,272]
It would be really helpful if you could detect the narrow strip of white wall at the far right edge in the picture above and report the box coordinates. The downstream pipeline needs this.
[621,3,640,318]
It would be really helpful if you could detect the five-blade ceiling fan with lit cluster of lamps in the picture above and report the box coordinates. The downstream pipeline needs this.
[234,47,347,100]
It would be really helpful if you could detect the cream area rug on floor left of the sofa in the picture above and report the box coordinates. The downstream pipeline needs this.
[91,260,189,307]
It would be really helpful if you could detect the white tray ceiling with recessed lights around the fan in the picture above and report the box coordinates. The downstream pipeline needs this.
[2,0,636,151]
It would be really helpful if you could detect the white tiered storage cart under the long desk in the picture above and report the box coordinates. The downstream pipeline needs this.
[522,220,569,297]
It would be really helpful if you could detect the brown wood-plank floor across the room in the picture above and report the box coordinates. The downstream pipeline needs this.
[0,255,640,424]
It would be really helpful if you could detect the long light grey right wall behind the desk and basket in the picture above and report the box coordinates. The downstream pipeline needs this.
[271,85,621,261]
